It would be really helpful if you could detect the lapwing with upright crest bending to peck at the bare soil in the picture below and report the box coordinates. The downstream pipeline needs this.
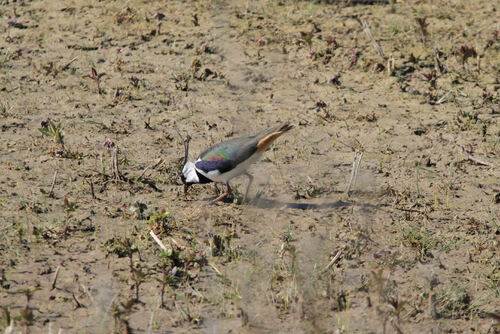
[181,122,293,204]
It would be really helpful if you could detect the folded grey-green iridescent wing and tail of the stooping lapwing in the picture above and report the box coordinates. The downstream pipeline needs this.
[195,123,292,175]
